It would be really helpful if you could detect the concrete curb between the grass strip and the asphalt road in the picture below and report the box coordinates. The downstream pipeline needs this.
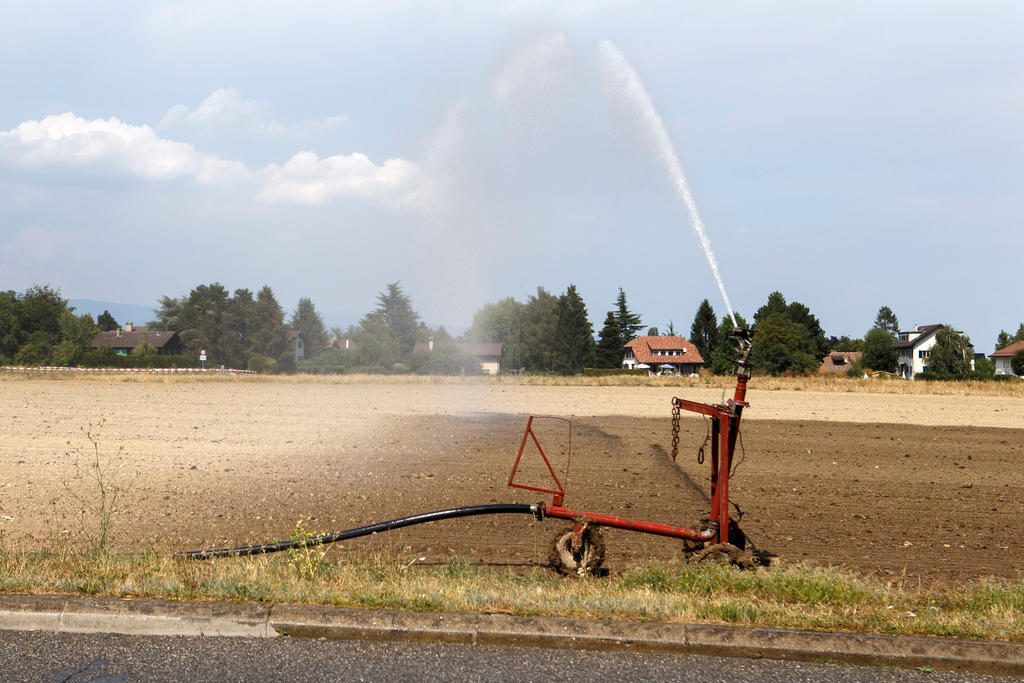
[0,595,1024,676]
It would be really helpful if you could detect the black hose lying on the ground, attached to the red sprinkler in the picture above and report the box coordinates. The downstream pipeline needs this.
[175,503,544,560]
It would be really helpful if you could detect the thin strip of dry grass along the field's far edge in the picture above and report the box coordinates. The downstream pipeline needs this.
[0,372,1024,398]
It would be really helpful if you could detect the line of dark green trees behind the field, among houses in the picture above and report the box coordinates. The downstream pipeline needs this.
[8,282,1024,379]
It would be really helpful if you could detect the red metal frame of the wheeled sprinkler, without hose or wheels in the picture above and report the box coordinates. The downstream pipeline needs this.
[509,370,749,548]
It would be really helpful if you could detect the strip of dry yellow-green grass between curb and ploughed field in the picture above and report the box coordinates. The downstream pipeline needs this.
[0,549,1024,640]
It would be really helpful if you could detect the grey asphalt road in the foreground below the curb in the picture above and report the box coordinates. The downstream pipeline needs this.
[0,631,1007,683]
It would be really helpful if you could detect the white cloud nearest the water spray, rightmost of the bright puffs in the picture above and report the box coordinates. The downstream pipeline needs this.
[259,152,431,208]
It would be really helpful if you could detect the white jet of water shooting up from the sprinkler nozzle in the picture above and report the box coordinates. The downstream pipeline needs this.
[598,40,738,327]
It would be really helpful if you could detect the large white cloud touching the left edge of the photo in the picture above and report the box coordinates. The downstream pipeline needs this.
[0,113,249,183]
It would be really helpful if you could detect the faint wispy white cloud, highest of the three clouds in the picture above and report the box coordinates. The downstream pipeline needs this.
[158,88,349,138]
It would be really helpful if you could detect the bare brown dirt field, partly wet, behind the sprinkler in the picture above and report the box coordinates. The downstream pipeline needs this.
[0,376,1024,585]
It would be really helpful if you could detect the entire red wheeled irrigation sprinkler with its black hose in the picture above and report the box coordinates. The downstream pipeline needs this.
[178,329,752,574]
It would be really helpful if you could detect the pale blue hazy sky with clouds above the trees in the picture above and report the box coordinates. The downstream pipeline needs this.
[0,0,1024,352]
